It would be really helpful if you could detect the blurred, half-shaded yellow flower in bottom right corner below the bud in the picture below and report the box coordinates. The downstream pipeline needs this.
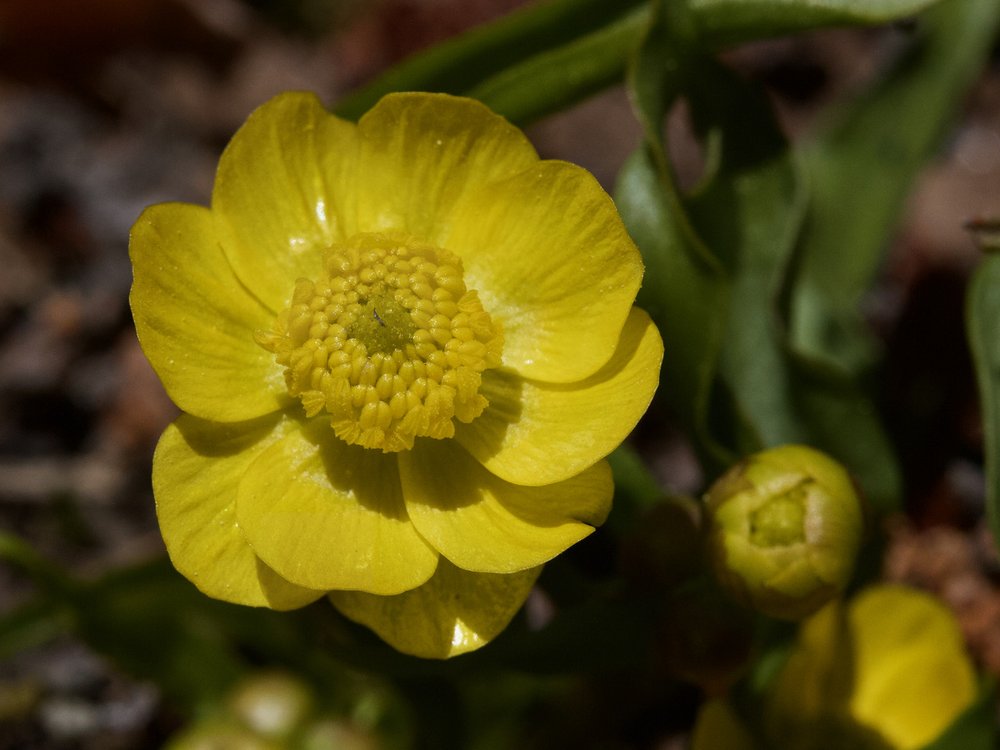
[692,585,977,750]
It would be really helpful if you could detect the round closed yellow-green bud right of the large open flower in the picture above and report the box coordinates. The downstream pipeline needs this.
[706,445,863,620]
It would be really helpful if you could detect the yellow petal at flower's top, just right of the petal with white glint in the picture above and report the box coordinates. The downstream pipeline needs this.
[355,93,538,246]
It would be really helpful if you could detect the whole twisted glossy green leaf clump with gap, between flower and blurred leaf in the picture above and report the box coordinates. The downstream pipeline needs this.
[616,5,899,510]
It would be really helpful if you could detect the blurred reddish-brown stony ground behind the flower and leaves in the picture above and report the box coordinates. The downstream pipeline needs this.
[0,0,1000,750]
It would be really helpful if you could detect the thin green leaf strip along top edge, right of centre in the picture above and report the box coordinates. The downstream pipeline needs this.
[690,0,937,49]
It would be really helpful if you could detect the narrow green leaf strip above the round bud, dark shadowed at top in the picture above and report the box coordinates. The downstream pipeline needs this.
[685,59,808,454]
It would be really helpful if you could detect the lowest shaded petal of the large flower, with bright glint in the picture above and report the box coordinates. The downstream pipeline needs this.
[330,559,541,659]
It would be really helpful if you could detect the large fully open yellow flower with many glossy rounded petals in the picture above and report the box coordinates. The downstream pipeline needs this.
[130,93,662,657]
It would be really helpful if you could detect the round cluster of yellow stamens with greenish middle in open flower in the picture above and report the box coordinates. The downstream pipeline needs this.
[255,234,503,453]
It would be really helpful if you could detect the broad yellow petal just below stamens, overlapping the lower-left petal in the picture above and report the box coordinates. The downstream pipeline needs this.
[236,420,437,594]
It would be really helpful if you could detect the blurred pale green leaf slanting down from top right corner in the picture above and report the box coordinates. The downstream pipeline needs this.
[790,0,1000,373]
